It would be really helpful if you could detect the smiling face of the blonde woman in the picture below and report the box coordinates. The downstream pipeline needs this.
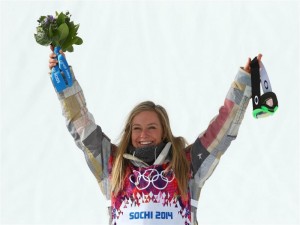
[131,111,163,148]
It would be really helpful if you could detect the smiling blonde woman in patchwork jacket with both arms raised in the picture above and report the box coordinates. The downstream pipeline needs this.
[49,48,262,225]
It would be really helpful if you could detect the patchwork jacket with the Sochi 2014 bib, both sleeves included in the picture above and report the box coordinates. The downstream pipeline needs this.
[52,68,251,225]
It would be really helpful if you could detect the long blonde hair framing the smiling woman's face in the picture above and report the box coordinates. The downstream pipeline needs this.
[111,101,190,196]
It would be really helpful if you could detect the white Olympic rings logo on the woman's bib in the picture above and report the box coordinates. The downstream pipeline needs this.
[129,169,175,191]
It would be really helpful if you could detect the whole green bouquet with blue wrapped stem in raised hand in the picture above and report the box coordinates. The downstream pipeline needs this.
[34,12,83,92]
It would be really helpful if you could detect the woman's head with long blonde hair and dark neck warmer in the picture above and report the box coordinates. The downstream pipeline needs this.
[112,101,189,201]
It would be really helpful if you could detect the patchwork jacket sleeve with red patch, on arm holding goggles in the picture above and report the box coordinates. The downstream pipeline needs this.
[191,68,251,189]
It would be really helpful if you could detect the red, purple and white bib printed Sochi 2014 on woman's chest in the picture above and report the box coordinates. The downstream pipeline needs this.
[112,164,191,225]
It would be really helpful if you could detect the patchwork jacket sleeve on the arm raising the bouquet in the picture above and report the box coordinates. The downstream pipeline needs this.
[52,67,115,199]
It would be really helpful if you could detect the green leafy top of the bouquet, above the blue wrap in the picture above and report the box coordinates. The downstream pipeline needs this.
[34,12,83,52]
